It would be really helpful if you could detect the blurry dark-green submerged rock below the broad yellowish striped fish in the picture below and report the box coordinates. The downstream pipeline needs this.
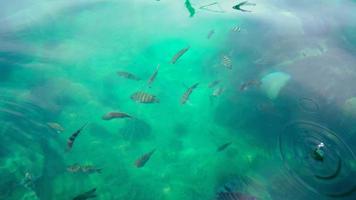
[119,119,152,141]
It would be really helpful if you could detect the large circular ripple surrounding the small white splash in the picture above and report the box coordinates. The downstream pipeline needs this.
[279,121,356,197]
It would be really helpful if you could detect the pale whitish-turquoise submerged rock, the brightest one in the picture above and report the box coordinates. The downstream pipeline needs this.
[261,72,290,99]
